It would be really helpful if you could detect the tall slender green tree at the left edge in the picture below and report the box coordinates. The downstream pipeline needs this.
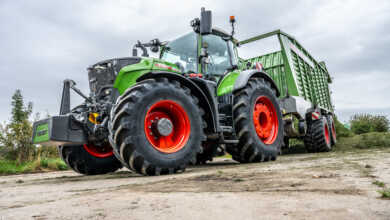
[0,89,35,162]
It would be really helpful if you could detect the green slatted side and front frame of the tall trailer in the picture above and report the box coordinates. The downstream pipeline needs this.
[239,30,333,112]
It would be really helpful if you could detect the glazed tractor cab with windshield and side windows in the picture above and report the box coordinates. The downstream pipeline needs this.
[160,28,238,78]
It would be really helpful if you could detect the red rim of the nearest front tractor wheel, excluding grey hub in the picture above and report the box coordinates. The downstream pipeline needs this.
[144,100,191,154]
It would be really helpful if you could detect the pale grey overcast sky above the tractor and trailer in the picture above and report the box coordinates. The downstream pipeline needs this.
[0,0,390,121]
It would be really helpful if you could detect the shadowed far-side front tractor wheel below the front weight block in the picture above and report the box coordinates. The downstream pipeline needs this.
[58,144,122,175]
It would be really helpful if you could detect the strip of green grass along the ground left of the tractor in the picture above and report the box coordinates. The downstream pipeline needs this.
[0,158,68,175]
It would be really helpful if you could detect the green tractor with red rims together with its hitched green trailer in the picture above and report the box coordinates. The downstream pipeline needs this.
[32,8,336,175]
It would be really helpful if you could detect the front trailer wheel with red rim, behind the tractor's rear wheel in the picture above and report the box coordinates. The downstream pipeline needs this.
[304,116,332,153]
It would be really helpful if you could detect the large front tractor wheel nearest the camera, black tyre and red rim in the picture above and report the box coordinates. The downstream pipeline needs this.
[109,78,206,175]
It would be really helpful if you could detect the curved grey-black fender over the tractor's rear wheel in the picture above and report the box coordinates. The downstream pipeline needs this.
[233,70,280,97]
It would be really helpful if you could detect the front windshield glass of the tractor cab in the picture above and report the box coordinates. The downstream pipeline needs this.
[161,32,198,73]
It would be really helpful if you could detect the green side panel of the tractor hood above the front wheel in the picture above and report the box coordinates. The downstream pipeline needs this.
[114,58,180,95]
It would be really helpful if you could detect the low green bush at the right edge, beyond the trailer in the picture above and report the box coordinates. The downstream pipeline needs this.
[350,114,389,134]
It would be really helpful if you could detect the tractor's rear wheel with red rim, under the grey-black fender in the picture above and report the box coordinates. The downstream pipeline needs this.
[229,78,283,162]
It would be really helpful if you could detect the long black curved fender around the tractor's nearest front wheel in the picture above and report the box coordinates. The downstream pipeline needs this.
[137,72,219,133]
